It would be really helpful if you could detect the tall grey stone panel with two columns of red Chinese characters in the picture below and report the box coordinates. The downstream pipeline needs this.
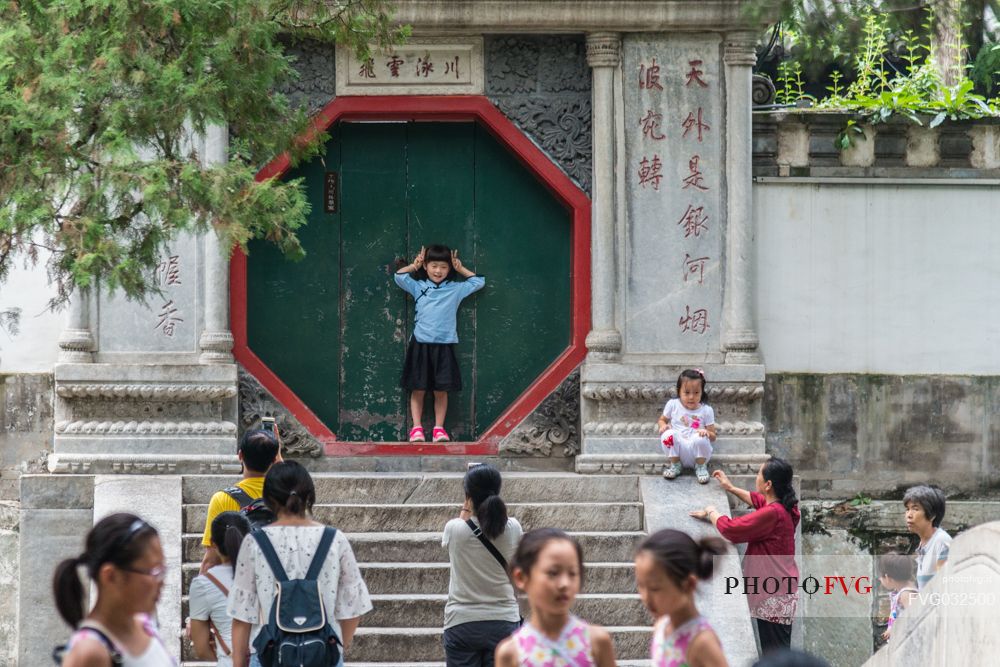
[624,35,725,352]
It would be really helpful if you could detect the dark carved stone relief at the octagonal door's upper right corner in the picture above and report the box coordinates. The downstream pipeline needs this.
[485,35,592,194]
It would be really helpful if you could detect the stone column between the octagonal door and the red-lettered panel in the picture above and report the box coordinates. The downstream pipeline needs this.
[587,32,622,360]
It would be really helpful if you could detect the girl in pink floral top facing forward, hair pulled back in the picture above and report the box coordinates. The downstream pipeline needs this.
[496,528,615,667]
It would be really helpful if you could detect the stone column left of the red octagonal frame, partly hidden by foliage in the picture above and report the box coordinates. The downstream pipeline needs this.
[198,125,233,364]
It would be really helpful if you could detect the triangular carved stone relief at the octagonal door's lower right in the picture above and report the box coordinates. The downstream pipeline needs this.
[500,370,580,457]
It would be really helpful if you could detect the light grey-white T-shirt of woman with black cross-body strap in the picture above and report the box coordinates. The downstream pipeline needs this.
[441,517,524,629]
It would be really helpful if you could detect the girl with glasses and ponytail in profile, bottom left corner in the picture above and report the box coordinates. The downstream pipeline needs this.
[52,513,175,667]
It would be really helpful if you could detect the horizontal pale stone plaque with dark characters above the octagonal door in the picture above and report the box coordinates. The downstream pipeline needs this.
[336,37,483,96]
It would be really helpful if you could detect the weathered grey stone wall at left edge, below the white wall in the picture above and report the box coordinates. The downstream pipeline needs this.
[0,374,53,501]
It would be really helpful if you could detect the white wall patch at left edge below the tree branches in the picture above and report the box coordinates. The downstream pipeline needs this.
[0,262,65,373]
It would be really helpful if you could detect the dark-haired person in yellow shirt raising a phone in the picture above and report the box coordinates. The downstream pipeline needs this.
[201,429,281,574]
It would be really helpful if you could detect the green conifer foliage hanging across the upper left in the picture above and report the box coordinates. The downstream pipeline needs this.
[0,0,408,302]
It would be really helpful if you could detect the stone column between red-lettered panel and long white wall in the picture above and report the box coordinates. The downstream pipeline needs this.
[722,32,760,364]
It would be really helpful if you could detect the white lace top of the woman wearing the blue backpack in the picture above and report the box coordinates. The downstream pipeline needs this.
[226,526,372,642]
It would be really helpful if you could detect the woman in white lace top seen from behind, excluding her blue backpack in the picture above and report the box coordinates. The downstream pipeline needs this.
[226,461,372,667]
